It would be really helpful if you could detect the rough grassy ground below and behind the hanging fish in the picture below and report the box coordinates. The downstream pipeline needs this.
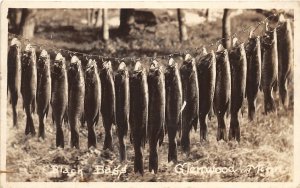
[6,10,294,182]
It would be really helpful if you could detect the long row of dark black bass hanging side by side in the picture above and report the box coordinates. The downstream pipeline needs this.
[8,17,293,174]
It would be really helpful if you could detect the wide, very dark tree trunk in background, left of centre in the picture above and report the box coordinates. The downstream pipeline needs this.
[119,9,135,35]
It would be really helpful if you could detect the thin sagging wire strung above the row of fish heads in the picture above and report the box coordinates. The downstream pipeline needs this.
[8,13,286,61]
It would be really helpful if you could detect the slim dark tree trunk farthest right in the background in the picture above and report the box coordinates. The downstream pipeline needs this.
[222,9,231,49]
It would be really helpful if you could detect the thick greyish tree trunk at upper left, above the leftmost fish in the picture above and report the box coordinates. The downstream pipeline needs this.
[19,9,37,39]
